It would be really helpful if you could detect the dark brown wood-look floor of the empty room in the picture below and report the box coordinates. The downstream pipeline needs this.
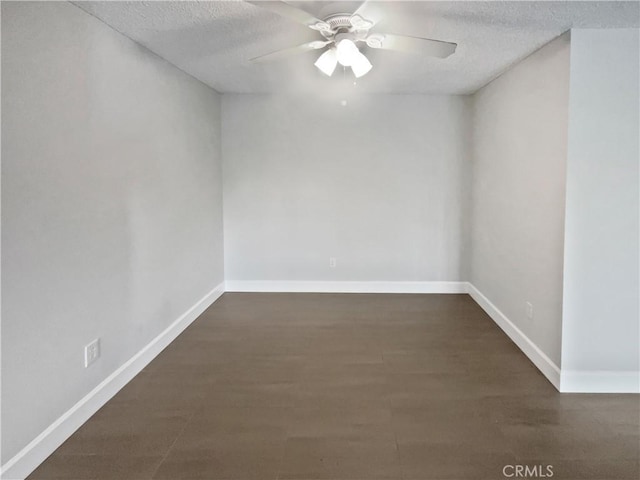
[29,293,640,480]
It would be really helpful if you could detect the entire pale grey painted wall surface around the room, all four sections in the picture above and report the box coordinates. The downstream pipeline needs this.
[1,9,638,474]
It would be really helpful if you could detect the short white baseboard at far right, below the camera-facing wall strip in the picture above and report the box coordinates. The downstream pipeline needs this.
[560,370,640,393]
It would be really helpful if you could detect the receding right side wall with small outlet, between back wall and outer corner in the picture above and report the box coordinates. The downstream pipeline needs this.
[470,35,570,368]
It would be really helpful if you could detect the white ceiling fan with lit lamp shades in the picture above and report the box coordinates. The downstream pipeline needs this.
[248,0,457,78]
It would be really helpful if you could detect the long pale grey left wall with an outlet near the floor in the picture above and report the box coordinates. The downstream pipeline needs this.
[2,2,223,463]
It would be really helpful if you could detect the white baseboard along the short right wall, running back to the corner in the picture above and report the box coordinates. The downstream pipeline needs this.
[468,283,560,390]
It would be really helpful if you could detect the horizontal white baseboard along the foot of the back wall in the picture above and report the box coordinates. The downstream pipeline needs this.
[225,280,467,293]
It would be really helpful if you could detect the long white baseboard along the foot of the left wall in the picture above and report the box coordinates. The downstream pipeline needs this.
[0,283,224,480]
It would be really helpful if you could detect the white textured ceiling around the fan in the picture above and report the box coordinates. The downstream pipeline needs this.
[74,0,640,94]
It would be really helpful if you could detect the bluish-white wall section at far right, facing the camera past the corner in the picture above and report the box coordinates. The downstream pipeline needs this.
[562,29,640,388]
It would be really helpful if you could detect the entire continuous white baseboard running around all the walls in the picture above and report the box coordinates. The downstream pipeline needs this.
[6,281,640,480]
